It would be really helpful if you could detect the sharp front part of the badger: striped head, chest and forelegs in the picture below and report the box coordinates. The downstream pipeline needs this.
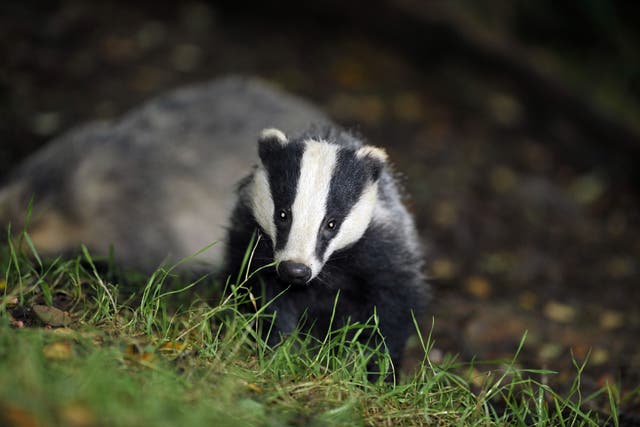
[226,126,426,376]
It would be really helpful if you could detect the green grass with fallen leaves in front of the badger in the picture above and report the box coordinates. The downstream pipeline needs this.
[0,233,619,427]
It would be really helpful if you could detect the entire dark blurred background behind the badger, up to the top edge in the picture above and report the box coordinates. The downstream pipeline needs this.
[0,0,640,412]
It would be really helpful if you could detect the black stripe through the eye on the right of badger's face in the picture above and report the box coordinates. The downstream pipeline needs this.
[316,149,369,259]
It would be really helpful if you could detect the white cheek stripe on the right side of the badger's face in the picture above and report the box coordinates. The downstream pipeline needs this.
[323,183,378,262]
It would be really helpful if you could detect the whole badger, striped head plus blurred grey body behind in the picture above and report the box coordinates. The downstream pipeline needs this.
[0,76,426,374]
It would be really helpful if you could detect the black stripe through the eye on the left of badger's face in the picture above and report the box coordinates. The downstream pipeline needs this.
[262,142,304,250]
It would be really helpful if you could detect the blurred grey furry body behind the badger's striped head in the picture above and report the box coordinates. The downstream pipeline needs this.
[0,77,329,272]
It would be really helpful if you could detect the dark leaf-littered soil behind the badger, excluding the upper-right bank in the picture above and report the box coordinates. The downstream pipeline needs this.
[0,0,640,413]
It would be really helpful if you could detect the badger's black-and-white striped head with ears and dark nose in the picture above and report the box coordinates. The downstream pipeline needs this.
[249,129,387,284]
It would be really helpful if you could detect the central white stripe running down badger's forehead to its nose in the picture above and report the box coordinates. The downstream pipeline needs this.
[275,141,338,277]
